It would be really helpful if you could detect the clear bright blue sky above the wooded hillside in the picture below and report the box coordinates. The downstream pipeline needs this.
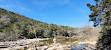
[0,0,95,27]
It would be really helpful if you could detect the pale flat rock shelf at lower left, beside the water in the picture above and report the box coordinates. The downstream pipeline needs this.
[0,39,46,50]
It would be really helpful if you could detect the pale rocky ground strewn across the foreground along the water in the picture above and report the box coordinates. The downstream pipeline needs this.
[0,38,95,50]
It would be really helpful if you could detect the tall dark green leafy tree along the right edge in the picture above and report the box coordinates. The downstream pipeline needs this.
[87,0,111,50]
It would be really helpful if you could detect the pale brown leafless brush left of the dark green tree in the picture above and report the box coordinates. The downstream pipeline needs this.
[75,25,101,41]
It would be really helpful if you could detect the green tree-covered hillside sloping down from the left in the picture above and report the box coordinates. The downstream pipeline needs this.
[0,8,74,39]
